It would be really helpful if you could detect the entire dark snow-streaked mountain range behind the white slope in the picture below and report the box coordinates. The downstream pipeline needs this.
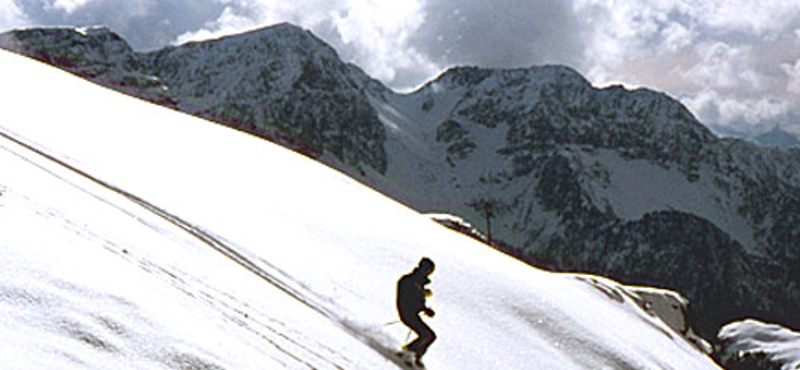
[0,24,800,337]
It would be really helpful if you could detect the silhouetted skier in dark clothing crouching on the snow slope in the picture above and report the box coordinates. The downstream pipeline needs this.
[397,257,436,366]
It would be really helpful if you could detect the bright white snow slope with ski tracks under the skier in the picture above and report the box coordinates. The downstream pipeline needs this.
[0,52,717,370]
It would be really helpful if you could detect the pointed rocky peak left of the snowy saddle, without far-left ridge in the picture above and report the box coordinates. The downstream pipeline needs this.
[144,24,386,173]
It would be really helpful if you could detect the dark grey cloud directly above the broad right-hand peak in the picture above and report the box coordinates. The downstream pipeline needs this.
[410,0,583,67]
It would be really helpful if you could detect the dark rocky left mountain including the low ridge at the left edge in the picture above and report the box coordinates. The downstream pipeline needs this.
[0,24,387,172]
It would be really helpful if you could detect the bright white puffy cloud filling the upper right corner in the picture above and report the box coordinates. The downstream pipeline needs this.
[575,0,800,131]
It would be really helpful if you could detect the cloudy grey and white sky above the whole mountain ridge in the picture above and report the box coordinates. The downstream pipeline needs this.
[0,0,800,134]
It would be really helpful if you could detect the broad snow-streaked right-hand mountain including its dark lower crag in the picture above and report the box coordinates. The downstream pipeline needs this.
[378,66,800,336]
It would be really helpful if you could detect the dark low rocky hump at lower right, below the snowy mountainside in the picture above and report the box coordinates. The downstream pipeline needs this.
[538,211,794,335]
